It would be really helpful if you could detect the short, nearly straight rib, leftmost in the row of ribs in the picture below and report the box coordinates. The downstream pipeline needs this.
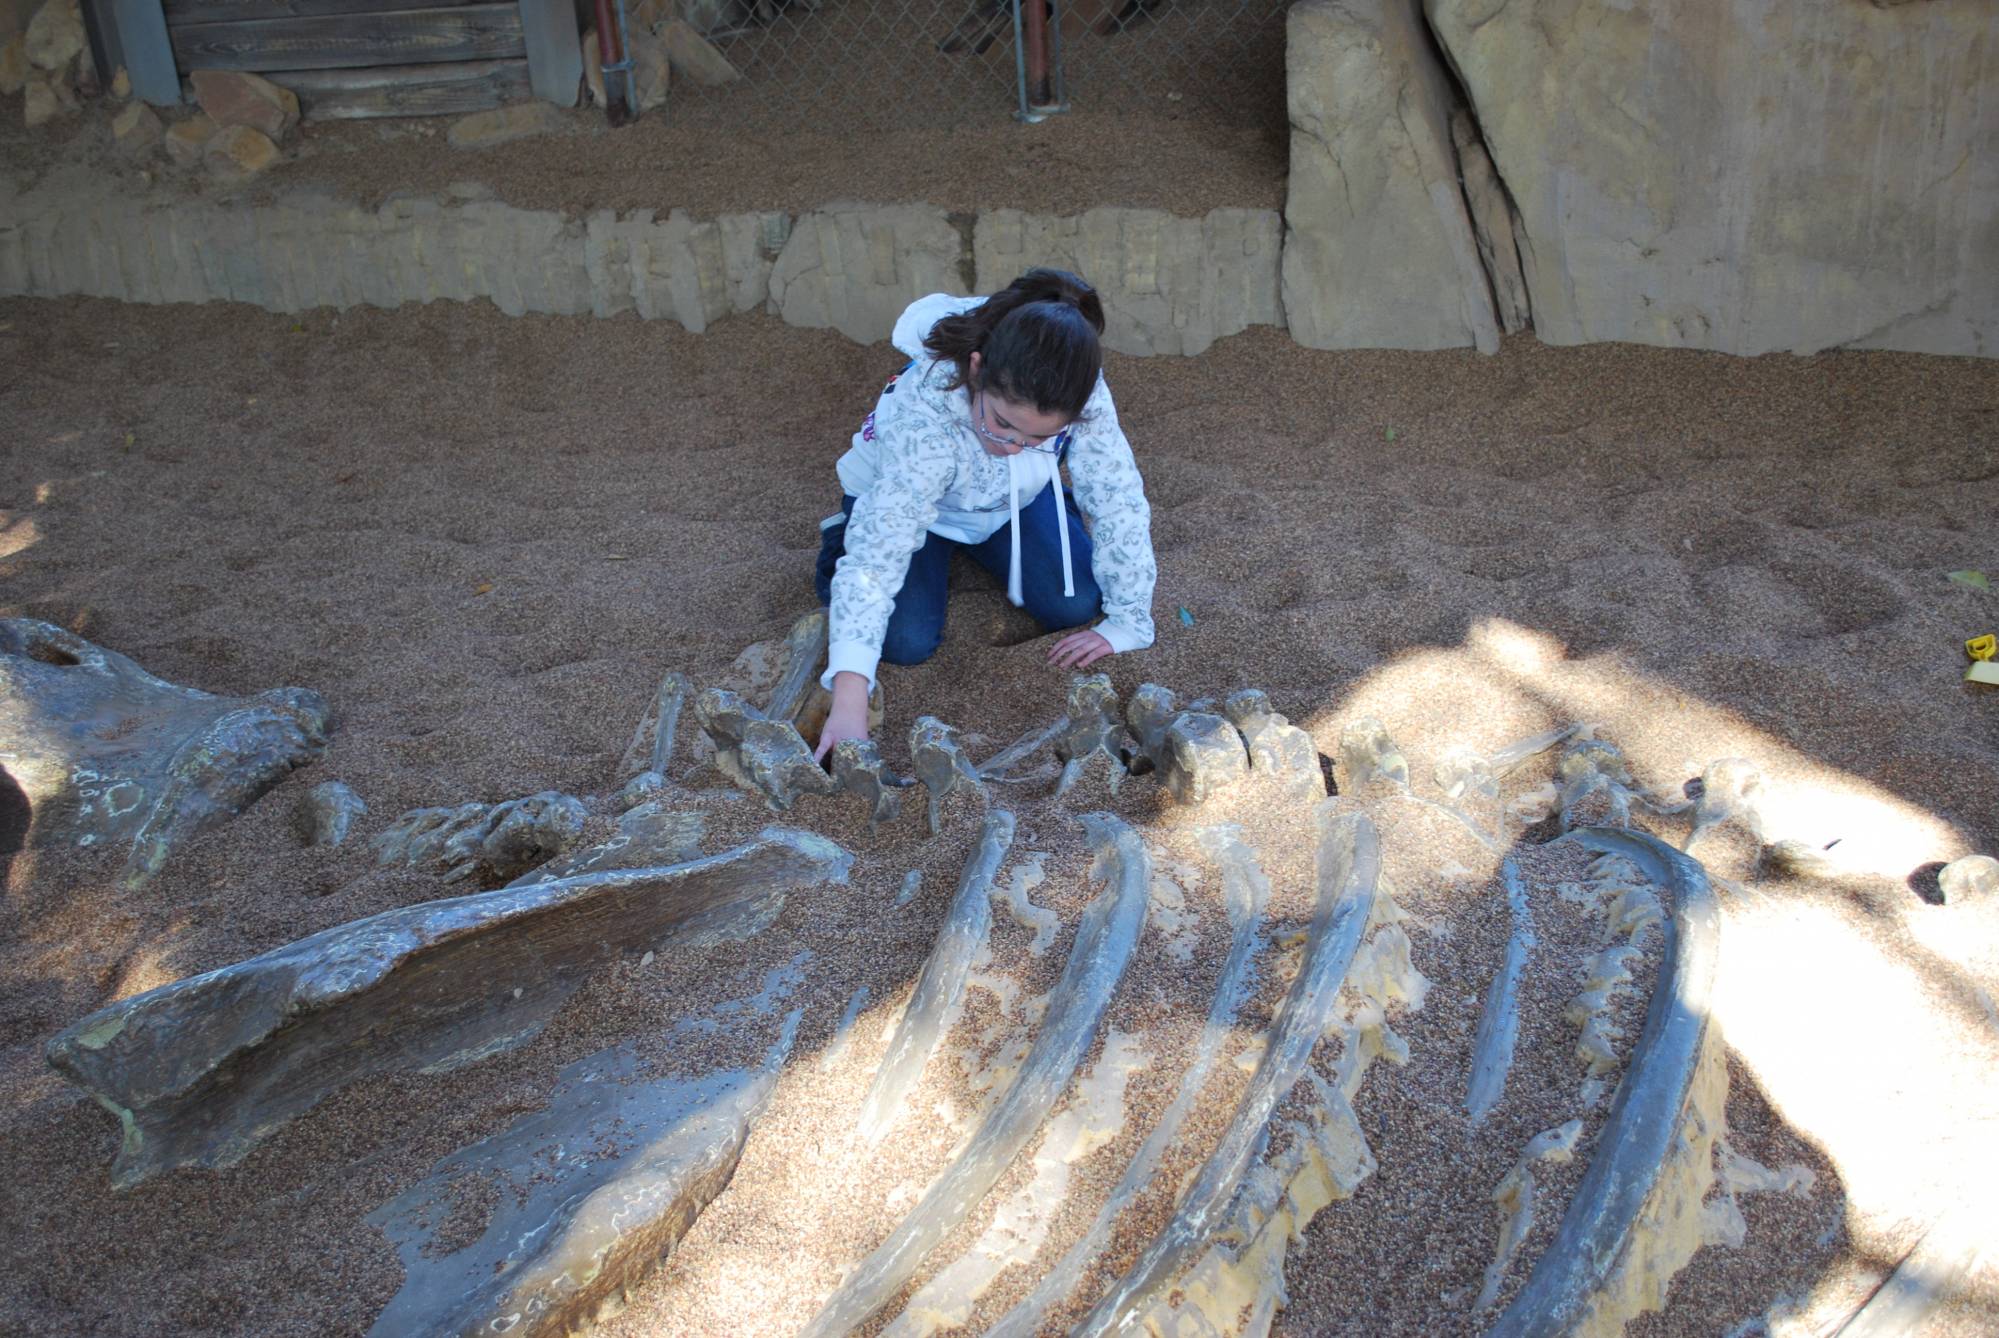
[860,808,1013,1142]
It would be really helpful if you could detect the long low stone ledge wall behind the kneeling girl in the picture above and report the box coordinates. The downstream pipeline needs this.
[0,170,1283,354]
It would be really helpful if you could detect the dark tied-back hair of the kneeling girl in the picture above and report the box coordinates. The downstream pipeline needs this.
[924,270,1103,418]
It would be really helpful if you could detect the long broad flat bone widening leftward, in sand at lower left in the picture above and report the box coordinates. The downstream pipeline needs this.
[48,828,852,1188]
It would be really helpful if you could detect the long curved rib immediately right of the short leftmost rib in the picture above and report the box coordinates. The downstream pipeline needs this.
[804,814,1151,1338]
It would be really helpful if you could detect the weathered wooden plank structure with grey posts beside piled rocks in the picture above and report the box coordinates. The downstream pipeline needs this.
[84,0,584,118]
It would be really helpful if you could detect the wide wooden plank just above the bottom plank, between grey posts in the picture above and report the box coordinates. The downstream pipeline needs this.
[168,0,528,70]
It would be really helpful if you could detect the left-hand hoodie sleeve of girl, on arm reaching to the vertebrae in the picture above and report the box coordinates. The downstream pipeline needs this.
[820,368,958,690]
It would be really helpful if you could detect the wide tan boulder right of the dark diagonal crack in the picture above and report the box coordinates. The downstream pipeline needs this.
[1423,0,1999,356]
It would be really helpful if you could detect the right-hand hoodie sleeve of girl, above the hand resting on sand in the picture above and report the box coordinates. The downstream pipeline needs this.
[1069,380,1159,652]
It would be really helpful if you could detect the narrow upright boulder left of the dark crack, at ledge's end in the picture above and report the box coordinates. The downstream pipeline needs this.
[1283,0,1499,352]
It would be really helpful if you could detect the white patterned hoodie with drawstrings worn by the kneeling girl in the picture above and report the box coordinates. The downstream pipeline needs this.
[822,292,1159,688]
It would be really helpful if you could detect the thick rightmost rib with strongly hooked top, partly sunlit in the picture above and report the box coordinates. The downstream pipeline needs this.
[1487,828,1729,1338]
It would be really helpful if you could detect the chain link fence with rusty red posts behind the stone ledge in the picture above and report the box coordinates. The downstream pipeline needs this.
[674,0,1285,130]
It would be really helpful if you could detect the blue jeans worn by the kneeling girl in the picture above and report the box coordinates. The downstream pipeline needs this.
[814,484,1103,664]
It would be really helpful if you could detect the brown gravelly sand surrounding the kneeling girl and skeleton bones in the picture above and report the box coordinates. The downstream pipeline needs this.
[0,300,1999,1334]
